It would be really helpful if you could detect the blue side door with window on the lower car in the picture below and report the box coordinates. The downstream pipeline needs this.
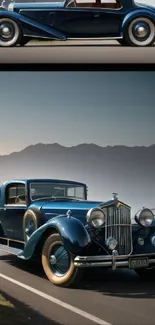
[1,183,27,241]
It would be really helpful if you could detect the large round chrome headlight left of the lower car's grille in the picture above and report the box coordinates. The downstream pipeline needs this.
[87,208,105,228]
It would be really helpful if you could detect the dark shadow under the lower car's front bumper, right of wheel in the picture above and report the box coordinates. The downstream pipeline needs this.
[80,269,155,299]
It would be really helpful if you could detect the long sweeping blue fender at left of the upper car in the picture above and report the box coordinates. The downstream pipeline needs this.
[0,9,66,40]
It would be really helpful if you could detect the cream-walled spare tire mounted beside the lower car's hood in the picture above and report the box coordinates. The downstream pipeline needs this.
[23,210,39,243]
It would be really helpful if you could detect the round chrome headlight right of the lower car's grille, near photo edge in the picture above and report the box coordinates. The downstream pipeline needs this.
[135,208,154,227]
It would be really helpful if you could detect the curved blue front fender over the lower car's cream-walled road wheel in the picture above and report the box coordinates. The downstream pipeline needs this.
[18,216,91,259]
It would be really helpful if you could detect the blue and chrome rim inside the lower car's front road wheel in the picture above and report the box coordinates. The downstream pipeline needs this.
[48,244,70,277]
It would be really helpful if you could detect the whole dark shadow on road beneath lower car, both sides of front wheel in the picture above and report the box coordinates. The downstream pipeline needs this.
[0,255,155,299]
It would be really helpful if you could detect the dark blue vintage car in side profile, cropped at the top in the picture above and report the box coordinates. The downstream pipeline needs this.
[0,0,155,46]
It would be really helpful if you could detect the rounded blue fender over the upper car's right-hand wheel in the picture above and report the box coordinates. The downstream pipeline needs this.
[121,9,155,36]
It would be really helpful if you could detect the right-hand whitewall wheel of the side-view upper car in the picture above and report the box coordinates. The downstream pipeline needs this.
[123,17,155,47]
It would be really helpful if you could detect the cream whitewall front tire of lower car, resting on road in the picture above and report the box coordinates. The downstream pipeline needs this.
[41,234,82,287]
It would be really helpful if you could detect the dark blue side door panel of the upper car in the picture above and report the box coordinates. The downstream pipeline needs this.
[52,0,122,38]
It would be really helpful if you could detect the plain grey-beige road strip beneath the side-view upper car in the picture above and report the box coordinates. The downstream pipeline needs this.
[0,41,155,64]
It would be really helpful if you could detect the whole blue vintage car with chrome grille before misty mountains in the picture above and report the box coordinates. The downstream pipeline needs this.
[0,179,155,286]
